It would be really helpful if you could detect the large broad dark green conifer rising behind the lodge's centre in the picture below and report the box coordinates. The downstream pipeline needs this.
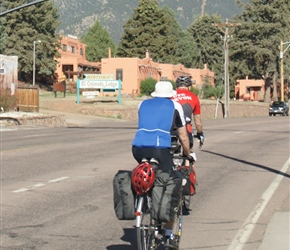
[118,0,182,63]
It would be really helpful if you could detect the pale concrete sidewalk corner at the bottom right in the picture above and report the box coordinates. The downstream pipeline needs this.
[259,212,290,250]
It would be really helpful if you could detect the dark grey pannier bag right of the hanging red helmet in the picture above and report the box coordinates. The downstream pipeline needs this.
[152,170,182,222]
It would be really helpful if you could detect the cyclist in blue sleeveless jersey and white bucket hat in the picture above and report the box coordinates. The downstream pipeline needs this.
[132,81,192,247]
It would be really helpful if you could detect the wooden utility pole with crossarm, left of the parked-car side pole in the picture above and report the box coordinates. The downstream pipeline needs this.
[214,19,241,118]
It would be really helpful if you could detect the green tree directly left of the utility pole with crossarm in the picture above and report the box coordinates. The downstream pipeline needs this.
[188,14,223,79]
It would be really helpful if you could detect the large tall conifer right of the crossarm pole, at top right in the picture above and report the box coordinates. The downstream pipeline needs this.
[230,0,290,102]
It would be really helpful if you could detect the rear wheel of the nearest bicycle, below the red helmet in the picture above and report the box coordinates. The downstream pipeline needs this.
[136,209,155,250]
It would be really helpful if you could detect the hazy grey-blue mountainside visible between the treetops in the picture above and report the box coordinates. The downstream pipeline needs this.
[53,0,248,45]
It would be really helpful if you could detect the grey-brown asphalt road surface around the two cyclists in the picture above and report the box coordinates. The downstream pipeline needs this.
[0,117,290,250]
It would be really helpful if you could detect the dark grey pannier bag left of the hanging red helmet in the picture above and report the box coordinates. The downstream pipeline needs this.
[113,170,135,220]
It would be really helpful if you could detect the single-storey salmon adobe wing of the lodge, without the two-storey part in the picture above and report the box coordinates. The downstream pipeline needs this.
[101,51,214,96]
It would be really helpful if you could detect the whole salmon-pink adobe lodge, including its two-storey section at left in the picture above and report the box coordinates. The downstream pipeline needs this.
[56,35,214,96]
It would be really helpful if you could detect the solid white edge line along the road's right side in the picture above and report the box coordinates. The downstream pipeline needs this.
[227,158,290,250]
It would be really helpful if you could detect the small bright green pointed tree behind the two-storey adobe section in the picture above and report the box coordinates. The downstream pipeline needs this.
[82,21,116,62]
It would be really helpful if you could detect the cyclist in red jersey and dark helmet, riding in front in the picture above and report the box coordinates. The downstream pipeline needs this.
[172,76,205,148]
